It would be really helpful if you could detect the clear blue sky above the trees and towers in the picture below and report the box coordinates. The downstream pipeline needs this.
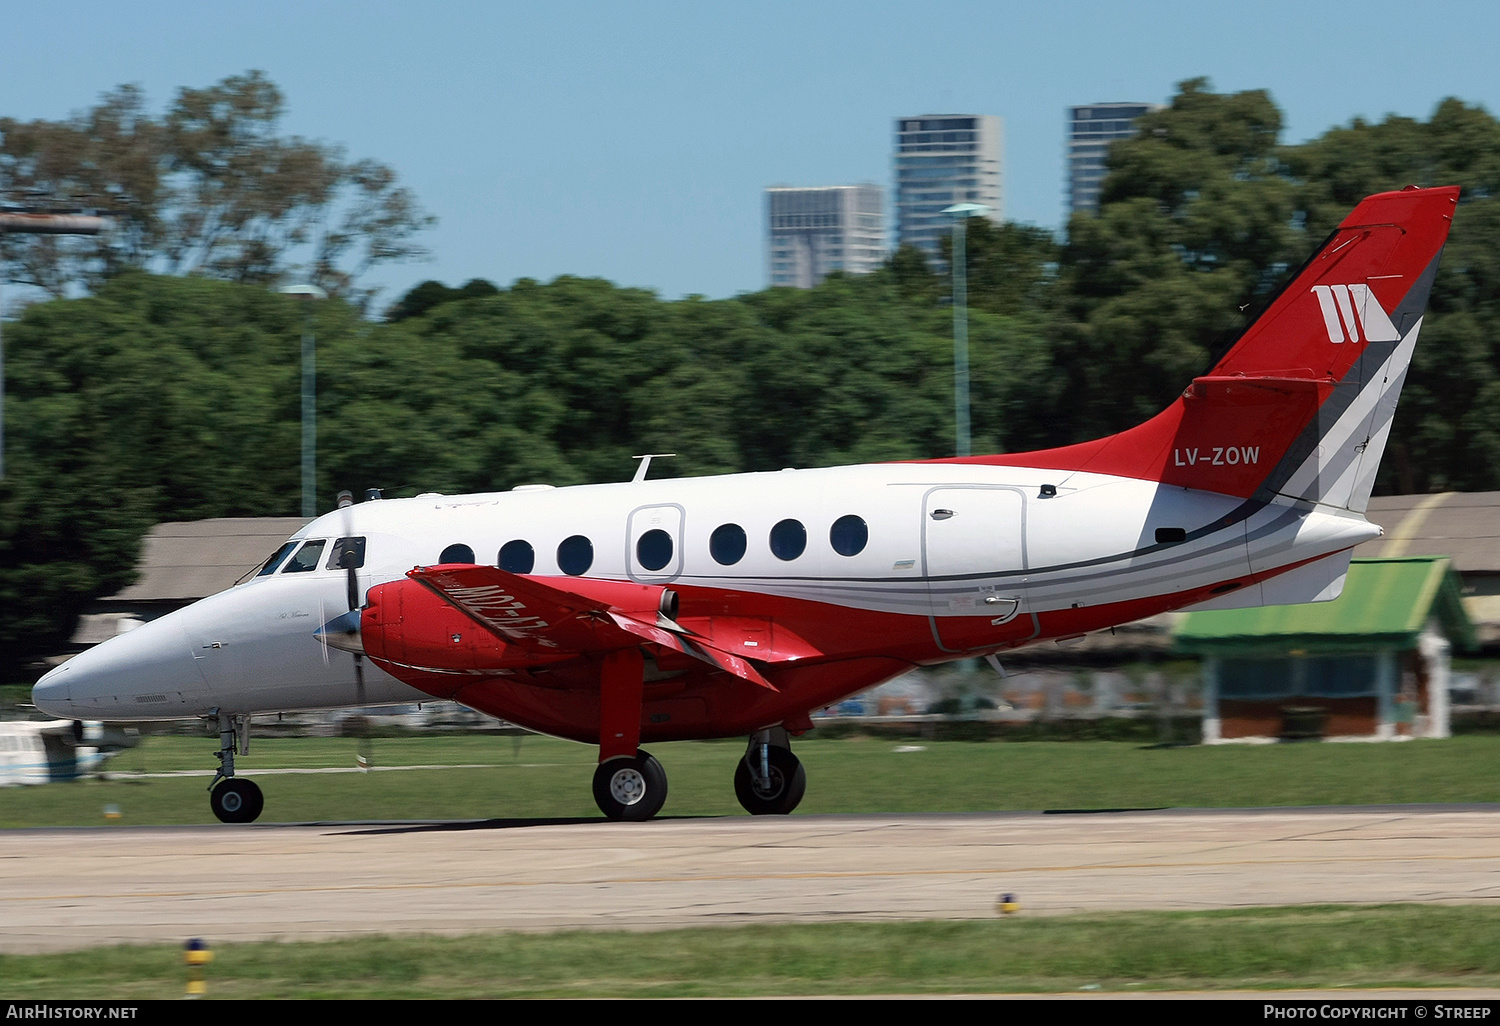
[0,0,1500,303]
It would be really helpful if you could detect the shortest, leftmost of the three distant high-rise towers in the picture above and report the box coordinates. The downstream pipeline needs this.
[765,185,885,288]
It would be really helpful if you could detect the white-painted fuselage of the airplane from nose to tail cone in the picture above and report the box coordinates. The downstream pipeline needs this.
[26,464,1379,720]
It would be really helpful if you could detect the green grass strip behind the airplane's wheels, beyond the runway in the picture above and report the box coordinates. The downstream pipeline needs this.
[0,735,1500,828]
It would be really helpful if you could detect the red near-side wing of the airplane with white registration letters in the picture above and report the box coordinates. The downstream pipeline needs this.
[407,564,776,692]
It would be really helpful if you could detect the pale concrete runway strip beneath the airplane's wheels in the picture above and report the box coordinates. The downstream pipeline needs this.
[0,806,1500,953]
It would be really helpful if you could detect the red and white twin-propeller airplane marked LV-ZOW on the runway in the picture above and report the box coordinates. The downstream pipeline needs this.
[33,188,1458,822]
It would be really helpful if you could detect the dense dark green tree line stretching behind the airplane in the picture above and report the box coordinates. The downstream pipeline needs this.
[0,80,1500,675]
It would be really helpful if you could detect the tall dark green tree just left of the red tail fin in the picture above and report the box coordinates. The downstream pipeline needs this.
[1055,80,1305,441]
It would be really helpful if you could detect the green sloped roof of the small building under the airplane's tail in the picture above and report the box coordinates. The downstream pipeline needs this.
[1176,557,1475,656]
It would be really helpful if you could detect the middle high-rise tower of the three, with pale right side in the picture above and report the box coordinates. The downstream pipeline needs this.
[896,114,1005,257]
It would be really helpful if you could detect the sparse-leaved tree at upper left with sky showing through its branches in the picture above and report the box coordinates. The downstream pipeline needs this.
[0,71,434,305]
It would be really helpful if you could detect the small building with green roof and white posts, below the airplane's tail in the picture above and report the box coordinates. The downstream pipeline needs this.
[1176,557,1476,744]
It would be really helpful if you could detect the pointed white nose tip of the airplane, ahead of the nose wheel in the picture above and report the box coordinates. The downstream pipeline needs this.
[32,617,204,720]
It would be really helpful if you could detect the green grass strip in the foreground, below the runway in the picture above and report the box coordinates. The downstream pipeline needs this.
[0,906,1500,1001]
